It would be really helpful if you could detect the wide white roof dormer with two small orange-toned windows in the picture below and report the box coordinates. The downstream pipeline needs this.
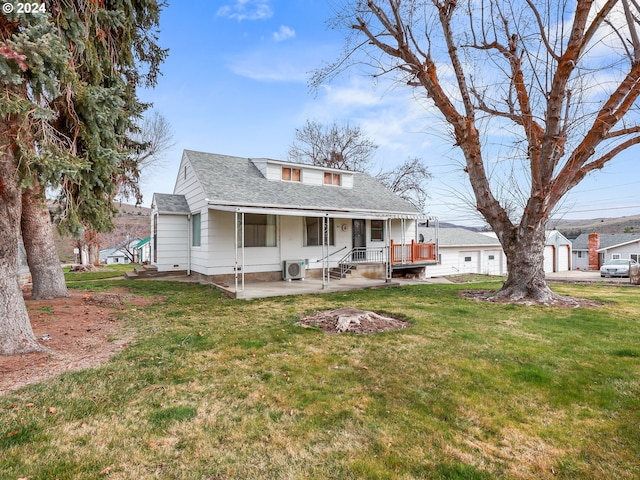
[251,159,353,188]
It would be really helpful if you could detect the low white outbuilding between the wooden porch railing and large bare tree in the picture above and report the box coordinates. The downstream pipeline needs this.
[418,227,507,277]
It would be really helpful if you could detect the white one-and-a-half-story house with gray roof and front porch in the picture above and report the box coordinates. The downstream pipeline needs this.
[151,150,436,292]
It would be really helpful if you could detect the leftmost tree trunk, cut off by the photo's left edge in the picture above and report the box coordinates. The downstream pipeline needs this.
[0,142,45,355]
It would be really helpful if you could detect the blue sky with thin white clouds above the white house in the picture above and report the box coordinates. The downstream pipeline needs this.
[141,0,640,225]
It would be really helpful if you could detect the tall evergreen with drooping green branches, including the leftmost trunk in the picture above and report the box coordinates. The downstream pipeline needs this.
[0,0,167,353]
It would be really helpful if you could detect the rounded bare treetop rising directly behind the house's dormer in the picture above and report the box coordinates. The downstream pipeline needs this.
[289,120,378,172]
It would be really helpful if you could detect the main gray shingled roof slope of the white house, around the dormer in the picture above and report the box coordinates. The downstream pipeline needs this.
[184,150,421,215]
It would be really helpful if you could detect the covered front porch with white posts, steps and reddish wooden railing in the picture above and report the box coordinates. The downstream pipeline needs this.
[209,204,437,298]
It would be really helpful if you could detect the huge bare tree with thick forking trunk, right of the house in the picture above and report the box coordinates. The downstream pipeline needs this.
[312,0,640,302]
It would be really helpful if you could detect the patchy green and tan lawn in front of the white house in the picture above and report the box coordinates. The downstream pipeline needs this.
[0,281,640,480]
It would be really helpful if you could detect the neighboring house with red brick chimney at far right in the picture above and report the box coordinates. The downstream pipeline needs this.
[572,232,640,270]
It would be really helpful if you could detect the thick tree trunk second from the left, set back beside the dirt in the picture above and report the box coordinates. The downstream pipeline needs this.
[22,186,69,299]
